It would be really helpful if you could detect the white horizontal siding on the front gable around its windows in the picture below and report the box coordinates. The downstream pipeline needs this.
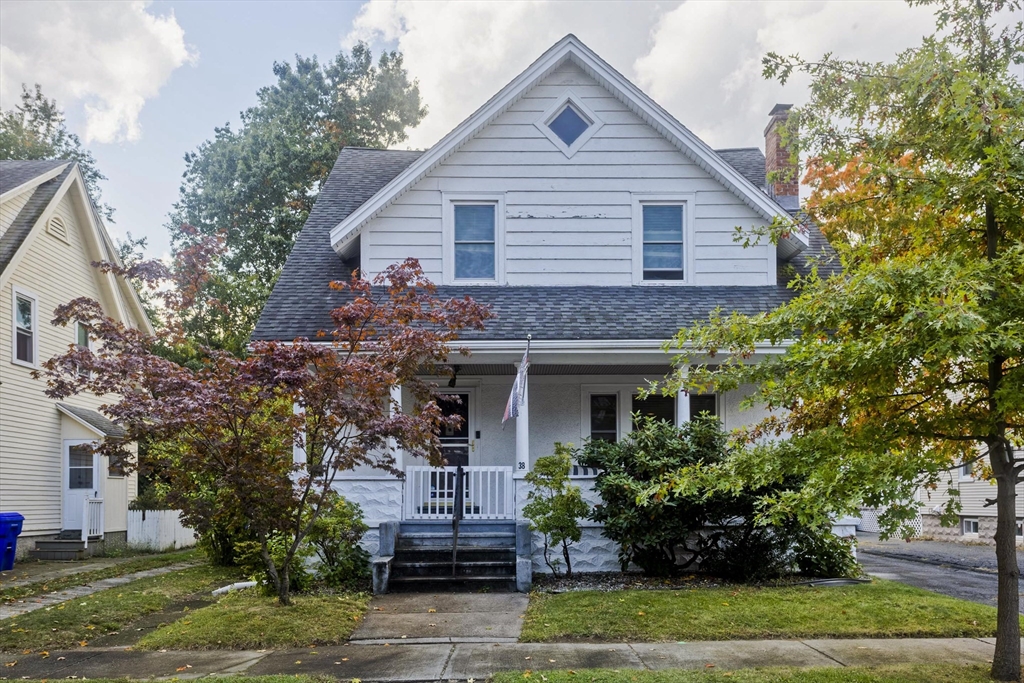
[360,63,775,286]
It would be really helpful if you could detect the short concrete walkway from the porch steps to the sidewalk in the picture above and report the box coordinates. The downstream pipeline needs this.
[351,593,529,645]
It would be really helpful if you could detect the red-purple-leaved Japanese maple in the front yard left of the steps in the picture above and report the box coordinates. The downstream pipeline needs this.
[40,241,490,604]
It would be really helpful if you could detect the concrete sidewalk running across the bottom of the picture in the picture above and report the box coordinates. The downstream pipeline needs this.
[0,638,1007,683]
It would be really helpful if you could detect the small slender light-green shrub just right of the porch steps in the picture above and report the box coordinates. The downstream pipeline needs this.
[522,443,590,577]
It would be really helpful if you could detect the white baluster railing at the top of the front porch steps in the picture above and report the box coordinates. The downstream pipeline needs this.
[404,467,515,519]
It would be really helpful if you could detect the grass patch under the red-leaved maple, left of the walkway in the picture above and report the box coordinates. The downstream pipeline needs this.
[138,590,370,651]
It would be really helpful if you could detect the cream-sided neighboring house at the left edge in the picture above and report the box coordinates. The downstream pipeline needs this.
[0,161,152,559]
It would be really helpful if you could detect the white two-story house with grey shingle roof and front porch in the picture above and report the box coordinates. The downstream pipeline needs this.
[254,35,830,589]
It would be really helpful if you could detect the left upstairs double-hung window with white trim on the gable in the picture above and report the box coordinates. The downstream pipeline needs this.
[443,195,505,285]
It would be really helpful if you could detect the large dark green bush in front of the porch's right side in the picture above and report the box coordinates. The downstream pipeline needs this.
[577,415,860,582]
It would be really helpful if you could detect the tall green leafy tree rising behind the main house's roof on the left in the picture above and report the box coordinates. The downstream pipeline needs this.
[168,44,426,350]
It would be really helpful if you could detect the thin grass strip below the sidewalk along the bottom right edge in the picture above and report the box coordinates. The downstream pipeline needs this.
[495,665,991,683]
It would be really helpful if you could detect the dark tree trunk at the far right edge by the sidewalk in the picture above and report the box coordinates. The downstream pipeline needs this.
[991,440,1021,681]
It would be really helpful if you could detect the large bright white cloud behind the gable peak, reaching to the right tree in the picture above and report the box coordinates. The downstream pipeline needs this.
[344,0,1011,152]
